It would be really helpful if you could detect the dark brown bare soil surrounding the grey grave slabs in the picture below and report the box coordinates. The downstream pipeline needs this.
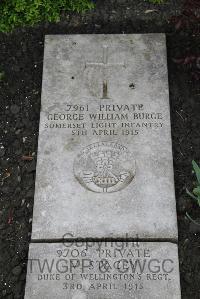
[0,0,200,299]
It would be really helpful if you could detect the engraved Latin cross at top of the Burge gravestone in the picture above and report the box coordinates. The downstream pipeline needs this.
[85,46,125,99]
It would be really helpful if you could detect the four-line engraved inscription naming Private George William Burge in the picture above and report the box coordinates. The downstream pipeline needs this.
[45,104,163,136]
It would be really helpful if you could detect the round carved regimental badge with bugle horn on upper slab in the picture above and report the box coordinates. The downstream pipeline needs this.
[74,142,136,193]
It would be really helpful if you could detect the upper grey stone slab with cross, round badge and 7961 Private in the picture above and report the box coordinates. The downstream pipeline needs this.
[32,34,177,239]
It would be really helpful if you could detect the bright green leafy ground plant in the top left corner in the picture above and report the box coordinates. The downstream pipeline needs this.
[0,0,94,32]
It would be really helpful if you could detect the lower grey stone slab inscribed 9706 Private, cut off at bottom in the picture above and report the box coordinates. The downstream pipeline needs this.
[25,242,181,299]
